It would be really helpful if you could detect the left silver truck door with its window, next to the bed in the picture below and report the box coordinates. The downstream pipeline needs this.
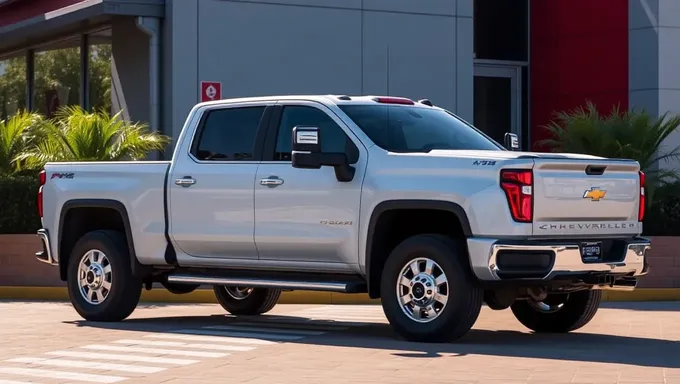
[168,104,266,259]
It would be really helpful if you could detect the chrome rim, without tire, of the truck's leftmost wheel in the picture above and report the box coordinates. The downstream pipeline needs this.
[78,249,113,305]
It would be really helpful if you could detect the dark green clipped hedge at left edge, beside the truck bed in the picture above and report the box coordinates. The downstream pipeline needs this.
[0,174,41,234]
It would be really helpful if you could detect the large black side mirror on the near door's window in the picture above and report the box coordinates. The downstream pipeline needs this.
[291,126,356,182]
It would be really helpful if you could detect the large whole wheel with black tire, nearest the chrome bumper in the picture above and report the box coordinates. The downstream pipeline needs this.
[380,235,483,342]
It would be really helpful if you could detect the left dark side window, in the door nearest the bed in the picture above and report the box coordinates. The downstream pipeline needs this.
[191,106,265,161]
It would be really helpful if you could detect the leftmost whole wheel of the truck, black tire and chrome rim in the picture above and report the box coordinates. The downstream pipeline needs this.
[67,230,142,321]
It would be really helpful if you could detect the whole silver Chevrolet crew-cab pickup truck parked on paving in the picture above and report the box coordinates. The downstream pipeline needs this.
[36,95,650,342]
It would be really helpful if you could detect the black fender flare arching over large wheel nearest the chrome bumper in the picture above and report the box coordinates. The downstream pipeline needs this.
[364,200,472,298]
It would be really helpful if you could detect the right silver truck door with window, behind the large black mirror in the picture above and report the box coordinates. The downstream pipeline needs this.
[255,101,367,270]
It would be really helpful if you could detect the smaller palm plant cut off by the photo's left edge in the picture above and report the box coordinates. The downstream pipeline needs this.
[0,111,46,174]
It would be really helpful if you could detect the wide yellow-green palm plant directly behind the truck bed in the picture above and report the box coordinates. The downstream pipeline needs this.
[16,106,170,169]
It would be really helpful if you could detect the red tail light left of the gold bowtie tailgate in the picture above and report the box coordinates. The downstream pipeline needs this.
[501,169,534,223]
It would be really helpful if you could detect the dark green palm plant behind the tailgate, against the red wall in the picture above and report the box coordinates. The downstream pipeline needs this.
[538,102,680,204]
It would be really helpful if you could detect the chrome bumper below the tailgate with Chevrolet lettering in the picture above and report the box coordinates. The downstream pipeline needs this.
[468,237,651,281]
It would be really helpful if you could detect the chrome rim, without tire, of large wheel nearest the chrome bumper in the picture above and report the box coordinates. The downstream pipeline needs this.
[397,257,449,323]
